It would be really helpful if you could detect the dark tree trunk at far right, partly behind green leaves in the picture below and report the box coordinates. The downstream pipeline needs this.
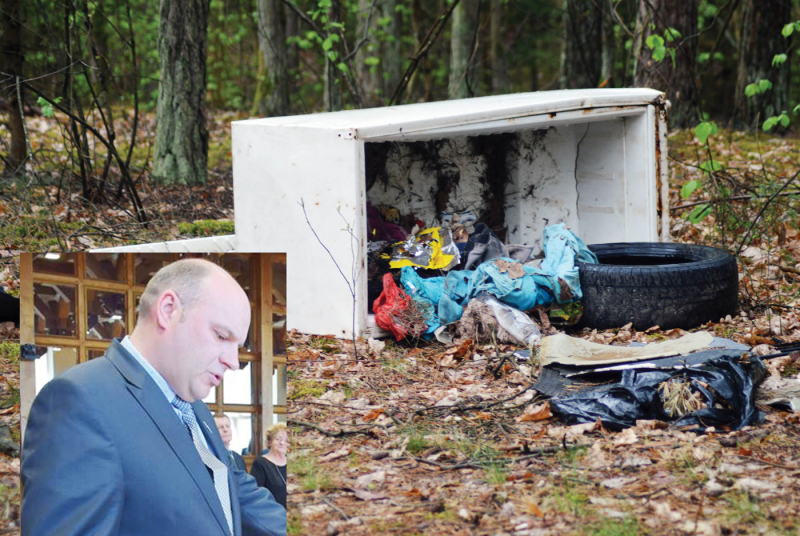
[734,0,793,128]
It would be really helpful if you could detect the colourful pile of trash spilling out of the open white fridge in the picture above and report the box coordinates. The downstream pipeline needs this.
[368,201,597,345]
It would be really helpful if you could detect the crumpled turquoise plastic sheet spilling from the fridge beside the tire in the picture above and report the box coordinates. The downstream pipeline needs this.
[400,223,597,324]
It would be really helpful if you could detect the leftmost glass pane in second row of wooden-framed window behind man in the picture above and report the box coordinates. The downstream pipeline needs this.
[33,283,78,337]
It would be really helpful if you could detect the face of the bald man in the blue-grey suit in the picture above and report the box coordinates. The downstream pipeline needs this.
[163,272,250,402]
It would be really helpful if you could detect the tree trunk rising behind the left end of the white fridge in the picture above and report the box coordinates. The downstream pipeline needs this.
[253,0,289,117]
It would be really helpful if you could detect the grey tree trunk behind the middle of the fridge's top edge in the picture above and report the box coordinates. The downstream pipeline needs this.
[448,0,479,99]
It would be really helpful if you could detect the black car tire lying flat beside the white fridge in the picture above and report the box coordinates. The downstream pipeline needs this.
[578,242,739,330]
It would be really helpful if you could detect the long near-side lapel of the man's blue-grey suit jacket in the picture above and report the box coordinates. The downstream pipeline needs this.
[106,341,236,536]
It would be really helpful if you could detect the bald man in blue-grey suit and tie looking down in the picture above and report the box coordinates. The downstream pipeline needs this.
[22,259,286,536]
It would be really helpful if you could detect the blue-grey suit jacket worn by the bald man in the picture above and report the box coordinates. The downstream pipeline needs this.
[22,341,286,536]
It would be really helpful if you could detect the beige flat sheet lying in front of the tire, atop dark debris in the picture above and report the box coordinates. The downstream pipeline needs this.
[539,331,714,366]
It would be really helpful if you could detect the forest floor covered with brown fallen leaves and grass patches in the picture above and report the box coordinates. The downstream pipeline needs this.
[6,114,800,535]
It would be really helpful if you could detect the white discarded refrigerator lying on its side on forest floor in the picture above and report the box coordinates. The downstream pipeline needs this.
[95,89,669,337]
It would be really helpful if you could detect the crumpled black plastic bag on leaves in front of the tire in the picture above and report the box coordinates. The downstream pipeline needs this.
[550,350,766,430]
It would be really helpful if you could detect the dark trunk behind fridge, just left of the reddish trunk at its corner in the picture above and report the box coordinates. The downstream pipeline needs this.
[559,0,604,89]
